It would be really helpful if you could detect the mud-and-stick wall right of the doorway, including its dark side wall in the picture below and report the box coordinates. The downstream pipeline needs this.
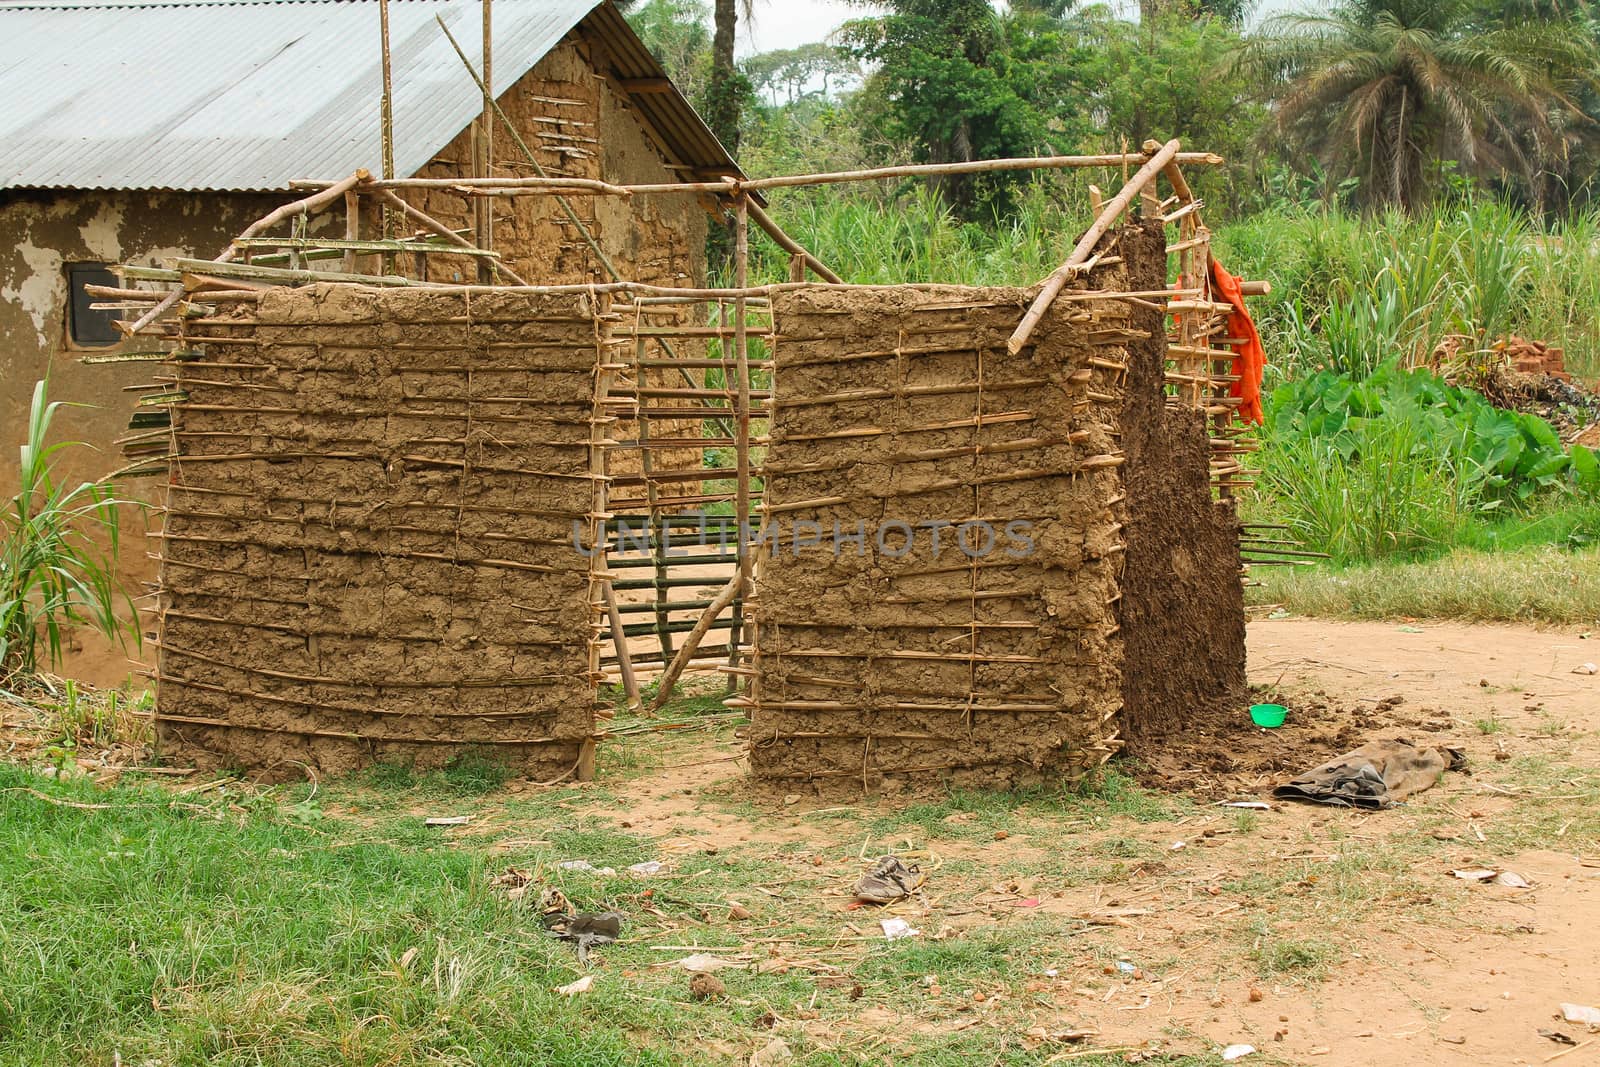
[749,226,1245,789]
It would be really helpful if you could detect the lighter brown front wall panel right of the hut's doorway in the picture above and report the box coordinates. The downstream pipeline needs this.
[749,279,1128,790]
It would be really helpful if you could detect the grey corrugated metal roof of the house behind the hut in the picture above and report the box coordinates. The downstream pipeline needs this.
[0,0,736,190]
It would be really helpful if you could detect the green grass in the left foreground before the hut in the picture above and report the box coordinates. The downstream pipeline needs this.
[0,765,1206,1067]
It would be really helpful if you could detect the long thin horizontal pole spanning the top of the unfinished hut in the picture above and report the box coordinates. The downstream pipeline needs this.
[290,150,1226,195]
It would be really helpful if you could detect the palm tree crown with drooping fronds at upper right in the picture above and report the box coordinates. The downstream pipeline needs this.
[1243,0,1597,210]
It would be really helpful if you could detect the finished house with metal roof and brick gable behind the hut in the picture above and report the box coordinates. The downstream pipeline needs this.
[0,0,738,677]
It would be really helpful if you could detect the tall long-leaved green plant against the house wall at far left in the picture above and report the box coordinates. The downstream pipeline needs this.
[0,381,138,686]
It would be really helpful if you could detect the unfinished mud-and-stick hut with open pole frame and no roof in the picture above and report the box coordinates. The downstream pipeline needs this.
[102,120,1273,789]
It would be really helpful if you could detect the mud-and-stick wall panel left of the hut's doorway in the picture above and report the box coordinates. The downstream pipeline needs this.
[157,285,602,777]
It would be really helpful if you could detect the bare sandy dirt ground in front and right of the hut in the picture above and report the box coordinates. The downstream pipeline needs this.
[13,617,1600,1067]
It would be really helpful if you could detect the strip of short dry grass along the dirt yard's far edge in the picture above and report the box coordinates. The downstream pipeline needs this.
[1246,545,1600,627]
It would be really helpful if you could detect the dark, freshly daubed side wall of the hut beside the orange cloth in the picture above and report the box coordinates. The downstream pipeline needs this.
[1118,224,1245,753]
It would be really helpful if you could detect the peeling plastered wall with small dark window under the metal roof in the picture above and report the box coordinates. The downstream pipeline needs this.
[0,190,282,604]
